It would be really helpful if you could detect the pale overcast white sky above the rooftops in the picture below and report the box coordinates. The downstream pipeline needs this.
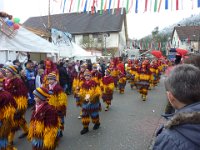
[0,0,200,39]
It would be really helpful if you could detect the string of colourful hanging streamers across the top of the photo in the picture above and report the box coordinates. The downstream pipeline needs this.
[53,0,200,15]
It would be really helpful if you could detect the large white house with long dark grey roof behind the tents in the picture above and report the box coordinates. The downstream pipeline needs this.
[23,8,128,56]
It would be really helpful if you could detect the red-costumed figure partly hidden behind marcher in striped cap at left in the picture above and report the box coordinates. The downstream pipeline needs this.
[42,59,59,88]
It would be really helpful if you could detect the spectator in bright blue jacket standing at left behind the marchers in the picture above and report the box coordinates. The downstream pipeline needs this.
[25,61,36,106]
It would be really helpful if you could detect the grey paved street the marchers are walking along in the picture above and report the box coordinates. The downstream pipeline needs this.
[14,79,167,150]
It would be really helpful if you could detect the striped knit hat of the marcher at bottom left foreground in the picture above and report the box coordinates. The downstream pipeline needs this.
[33,87,49,101]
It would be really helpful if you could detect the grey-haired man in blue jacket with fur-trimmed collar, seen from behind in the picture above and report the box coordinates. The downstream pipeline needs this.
[153,64,200,150]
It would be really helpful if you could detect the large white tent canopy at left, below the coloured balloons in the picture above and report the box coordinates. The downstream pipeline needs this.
[0,27,58,53]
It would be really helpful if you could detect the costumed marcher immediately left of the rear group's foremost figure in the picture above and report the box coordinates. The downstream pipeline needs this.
[130,60,140,89]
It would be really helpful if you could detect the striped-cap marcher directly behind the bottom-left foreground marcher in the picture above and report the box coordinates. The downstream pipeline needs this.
[47,73,67,137]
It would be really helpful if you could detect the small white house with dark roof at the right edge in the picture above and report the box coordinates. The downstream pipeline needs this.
[171,26,200,53]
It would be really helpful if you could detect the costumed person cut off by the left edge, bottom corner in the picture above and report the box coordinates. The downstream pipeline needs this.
[0,78,17,150]
